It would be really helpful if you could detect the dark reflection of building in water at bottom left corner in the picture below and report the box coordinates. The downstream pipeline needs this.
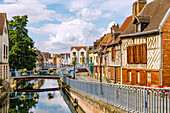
[0,95,9,113]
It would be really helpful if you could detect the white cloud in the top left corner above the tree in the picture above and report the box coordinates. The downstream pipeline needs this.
[0,0,57,22]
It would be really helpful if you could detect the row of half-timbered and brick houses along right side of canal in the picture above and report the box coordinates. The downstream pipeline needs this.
[89,0,170,86]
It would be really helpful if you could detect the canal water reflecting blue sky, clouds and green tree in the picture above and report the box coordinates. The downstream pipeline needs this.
[0,79,75,113]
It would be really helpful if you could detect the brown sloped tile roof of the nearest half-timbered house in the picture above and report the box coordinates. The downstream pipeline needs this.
[124,0,170,34]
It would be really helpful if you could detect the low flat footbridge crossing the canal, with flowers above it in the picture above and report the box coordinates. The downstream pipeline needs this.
[11,75,60,80]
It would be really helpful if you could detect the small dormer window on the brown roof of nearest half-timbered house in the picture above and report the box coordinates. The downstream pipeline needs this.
[133,16,150,32]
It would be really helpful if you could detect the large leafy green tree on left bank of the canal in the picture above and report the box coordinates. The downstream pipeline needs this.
[8,15,37,70]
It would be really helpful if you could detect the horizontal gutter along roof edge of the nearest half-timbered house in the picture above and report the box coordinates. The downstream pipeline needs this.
[119,29,159,38]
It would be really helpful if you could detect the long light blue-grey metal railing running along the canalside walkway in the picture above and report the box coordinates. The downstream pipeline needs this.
[59,71,170,113]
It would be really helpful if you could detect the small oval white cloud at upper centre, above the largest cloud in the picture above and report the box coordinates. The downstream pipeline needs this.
[77,8,102,21]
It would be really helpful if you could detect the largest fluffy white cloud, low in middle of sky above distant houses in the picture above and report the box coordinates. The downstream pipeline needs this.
[28,19,101,52]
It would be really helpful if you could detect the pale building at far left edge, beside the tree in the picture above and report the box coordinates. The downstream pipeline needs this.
[0,13,10,81]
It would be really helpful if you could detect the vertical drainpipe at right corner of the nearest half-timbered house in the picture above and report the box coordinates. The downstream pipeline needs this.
[159,29,162,86]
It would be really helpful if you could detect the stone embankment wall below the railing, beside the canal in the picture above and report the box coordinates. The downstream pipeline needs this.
[63,83,127,113]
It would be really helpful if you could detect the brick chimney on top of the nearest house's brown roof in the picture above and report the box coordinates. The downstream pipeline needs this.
[132,0,147,19]
